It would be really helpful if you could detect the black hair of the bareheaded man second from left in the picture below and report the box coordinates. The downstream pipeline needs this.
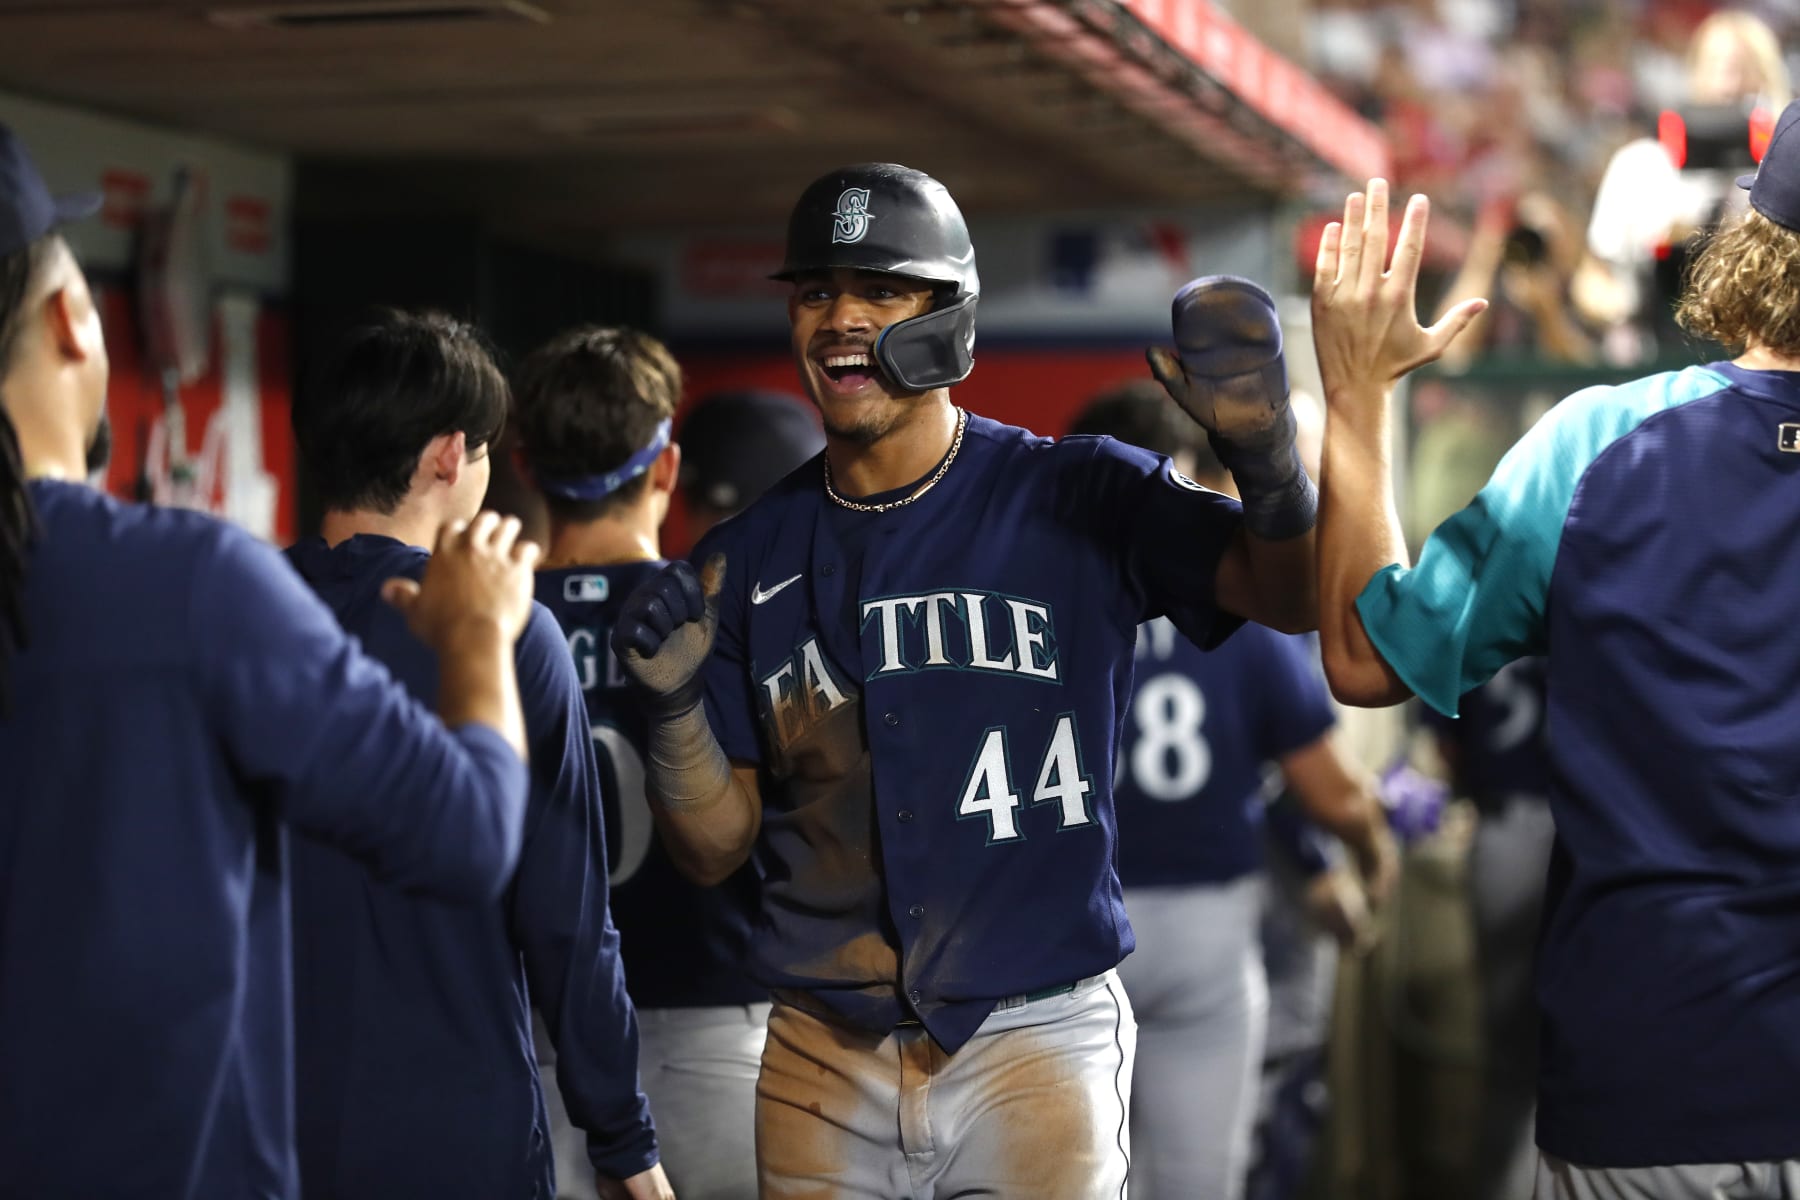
[293,308,508,513]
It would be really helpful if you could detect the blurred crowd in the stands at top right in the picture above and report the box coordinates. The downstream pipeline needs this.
[1310,0,1800,371]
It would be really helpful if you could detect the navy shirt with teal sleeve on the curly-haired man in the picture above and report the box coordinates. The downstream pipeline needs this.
[1357,363,1800,1166]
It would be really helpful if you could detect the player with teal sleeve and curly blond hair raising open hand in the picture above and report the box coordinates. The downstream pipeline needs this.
[1314,116,1800,1200]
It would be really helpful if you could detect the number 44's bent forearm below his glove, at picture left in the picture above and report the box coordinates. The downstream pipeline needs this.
[646,705,761,887]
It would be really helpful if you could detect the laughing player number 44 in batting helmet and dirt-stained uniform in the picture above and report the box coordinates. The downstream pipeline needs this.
[614,164,1314,1200]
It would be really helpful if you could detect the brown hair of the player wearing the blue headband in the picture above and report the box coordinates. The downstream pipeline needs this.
[515,326,680,522]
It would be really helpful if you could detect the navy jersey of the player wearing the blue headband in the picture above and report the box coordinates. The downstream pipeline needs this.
[538,561,769,1007]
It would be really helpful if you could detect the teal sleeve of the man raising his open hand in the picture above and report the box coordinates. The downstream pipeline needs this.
[1357,367,1730,716]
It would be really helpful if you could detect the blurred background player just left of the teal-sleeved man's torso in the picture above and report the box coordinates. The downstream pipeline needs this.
[1426,658,1555,1200]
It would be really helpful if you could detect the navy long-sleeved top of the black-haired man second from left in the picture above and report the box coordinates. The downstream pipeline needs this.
[288,534,657,1200]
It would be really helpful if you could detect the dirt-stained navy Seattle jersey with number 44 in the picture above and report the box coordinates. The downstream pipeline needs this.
[695,417,1240,1051]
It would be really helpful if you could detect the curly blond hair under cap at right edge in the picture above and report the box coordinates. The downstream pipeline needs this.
[1676,210,1800,358]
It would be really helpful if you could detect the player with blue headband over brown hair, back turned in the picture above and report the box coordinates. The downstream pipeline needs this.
[517,327,817,1200]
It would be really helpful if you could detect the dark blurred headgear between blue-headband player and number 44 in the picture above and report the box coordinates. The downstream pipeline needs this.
[679,390,824,513]
